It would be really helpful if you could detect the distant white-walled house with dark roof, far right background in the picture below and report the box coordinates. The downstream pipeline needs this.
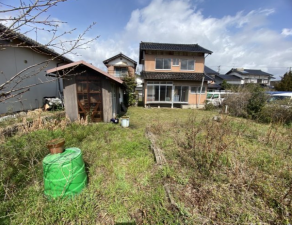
[226,68,274,86]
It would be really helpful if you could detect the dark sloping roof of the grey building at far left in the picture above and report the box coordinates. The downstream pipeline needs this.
[0,23,73,63]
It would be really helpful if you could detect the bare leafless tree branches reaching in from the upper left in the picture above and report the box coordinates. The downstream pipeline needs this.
[0,0,98,103]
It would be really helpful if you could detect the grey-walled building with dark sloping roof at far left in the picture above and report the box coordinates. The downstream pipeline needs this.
[0,24,72,114]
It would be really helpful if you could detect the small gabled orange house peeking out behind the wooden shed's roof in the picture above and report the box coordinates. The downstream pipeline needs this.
[103,53,137,78]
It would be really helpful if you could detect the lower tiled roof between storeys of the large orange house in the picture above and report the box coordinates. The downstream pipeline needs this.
[141,71,212,81]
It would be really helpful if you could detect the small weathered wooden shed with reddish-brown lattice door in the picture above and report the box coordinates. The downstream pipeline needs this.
[47,61,123,122]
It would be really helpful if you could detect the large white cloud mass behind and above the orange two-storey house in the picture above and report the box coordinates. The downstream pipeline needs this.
[60,0,292,76]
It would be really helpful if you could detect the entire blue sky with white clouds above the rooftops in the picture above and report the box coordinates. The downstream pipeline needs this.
[0,0,292,77]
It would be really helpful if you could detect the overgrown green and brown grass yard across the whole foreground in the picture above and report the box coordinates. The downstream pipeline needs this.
[0,108,292,224]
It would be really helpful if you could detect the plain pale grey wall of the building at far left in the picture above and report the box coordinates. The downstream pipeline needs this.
[0,47,67,114]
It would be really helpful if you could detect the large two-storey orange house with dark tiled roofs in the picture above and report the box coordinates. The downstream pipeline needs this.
[139,42,212,107]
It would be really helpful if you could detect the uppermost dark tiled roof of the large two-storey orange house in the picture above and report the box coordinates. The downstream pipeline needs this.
[139,42,213,63]
